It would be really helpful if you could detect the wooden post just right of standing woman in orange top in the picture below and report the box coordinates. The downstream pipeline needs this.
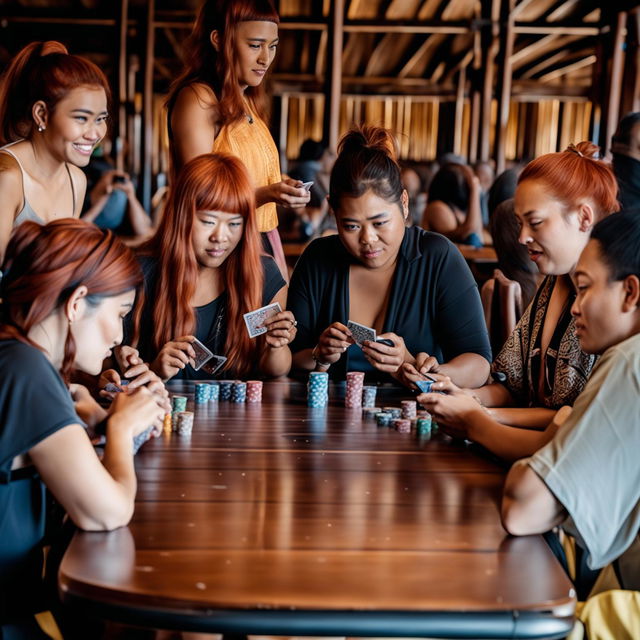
[324,0,345,150]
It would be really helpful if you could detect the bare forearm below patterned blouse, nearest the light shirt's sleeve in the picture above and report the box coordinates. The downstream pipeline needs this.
[468,410,555,461]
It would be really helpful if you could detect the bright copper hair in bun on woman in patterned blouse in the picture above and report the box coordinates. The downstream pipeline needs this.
[518,142,620,221]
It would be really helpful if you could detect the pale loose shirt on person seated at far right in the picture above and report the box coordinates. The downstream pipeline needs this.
[526,335,640,583]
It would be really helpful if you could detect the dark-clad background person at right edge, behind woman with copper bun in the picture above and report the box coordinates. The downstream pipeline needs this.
[611,112,640,209]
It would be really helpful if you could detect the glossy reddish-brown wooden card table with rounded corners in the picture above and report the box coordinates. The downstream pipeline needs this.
[59,381,575,638]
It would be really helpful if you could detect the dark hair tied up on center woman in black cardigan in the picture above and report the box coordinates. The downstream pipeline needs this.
[329,126,404,211]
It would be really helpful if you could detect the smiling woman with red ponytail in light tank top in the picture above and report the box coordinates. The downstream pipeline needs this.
[0,41,110,259]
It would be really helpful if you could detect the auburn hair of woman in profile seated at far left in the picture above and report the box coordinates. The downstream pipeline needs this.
[0,218,142,382]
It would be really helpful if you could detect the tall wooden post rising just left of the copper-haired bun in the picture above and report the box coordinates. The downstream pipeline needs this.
[495,0,515,174]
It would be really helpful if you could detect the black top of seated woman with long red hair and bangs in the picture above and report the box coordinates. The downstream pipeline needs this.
[131,256,287,380]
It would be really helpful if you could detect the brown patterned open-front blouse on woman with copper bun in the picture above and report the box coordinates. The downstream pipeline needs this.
[491,276,597,409]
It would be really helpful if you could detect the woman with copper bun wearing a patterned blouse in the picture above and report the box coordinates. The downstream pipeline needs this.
[412,142,619,459]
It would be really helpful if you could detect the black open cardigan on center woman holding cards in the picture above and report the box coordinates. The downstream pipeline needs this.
[287,227,491,381]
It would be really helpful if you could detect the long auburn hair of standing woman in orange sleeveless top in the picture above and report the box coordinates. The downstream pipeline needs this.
[167,0,280,130]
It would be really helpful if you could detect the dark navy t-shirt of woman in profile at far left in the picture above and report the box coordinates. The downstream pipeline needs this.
[0,340,82,624]
